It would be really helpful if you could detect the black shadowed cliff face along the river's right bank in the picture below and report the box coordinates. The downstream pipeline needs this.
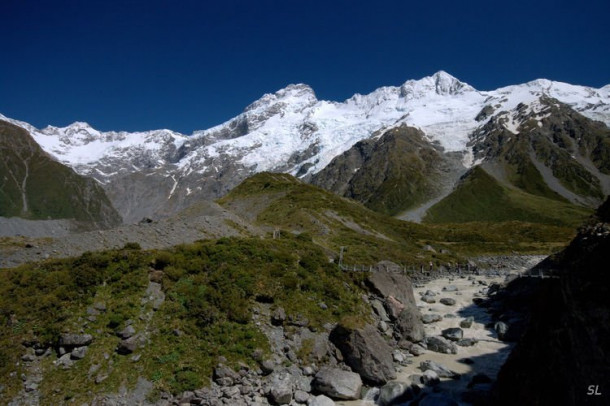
[496,199,610,405]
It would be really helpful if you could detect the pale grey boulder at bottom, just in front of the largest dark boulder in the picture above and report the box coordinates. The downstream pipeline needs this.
[312,368,362,400]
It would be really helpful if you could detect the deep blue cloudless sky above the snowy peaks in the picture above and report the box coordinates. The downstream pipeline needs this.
[0,0,610,134]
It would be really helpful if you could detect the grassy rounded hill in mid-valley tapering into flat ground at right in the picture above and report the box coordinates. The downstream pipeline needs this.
[219,173,582,266]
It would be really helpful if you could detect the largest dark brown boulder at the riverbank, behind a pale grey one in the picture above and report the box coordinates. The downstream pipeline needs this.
[329,324,396,385]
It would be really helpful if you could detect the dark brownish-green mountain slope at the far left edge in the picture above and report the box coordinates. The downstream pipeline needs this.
[0,120,121,230]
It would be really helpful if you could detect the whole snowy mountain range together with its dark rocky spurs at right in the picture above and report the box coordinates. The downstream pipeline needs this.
[2,72,610,223]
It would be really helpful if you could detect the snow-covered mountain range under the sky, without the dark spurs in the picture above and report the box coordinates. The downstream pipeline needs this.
[0,71,610,221]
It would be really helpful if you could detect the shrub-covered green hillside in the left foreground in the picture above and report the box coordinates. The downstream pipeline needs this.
[0,236,367,405]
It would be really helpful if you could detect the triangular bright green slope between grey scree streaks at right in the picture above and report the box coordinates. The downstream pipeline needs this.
[424,166,591,228]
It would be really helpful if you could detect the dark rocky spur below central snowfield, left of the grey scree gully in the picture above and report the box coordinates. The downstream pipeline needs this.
[310,125,466,215]
